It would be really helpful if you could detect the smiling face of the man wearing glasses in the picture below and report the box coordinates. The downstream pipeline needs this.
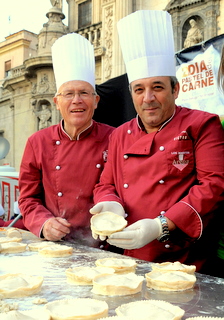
[54,80,99,134]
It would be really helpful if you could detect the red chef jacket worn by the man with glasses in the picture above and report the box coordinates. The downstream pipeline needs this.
[19,120,114,245]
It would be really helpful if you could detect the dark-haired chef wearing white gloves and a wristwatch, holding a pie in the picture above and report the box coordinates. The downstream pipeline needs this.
[91,11,224,272]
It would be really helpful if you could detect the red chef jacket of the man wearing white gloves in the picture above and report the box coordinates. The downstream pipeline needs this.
[94,107,224,270]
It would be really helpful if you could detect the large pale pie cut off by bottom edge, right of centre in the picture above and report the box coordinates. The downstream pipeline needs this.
[115,300,185,320]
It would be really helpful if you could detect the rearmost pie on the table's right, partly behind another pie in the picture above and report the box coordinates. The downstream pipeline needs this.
[151,261,196,274]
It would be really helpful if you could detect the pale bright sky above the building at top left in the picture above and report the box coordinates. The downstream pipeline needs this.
[0,0,68,42]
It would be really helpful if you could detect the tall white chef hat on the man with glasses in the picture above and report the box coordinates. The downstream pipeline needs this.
[51,33,95,90]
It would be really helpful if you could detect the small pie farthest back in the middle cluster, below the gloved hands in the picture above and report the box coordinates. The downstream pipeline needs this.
[95,258,137,273]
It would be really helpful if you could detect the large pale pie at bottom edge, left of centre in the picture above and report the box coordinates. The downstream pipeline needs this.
[45,298,108,320]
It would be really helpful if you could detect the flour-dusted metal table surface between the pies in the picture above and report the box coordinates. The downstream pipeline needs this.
[0,240,224,319]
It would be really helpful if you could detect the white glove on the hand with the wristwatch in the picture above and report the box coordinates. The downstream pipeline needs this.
[107,218,162,250]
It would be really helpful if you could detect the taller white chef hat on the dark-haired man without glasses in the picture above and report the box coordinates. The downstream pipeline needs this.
[117,10,176,83]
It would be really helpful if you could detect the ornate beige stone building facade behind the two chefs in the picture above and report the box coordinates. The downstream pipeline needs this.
[0,0,224,170]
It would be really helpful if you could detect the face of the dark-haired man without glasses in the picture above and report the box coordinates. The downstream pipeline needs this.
[131,77,179,133]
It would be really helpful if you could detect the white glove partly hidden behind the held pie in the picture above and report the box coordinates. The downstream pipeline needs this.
[89,201,126,241]
